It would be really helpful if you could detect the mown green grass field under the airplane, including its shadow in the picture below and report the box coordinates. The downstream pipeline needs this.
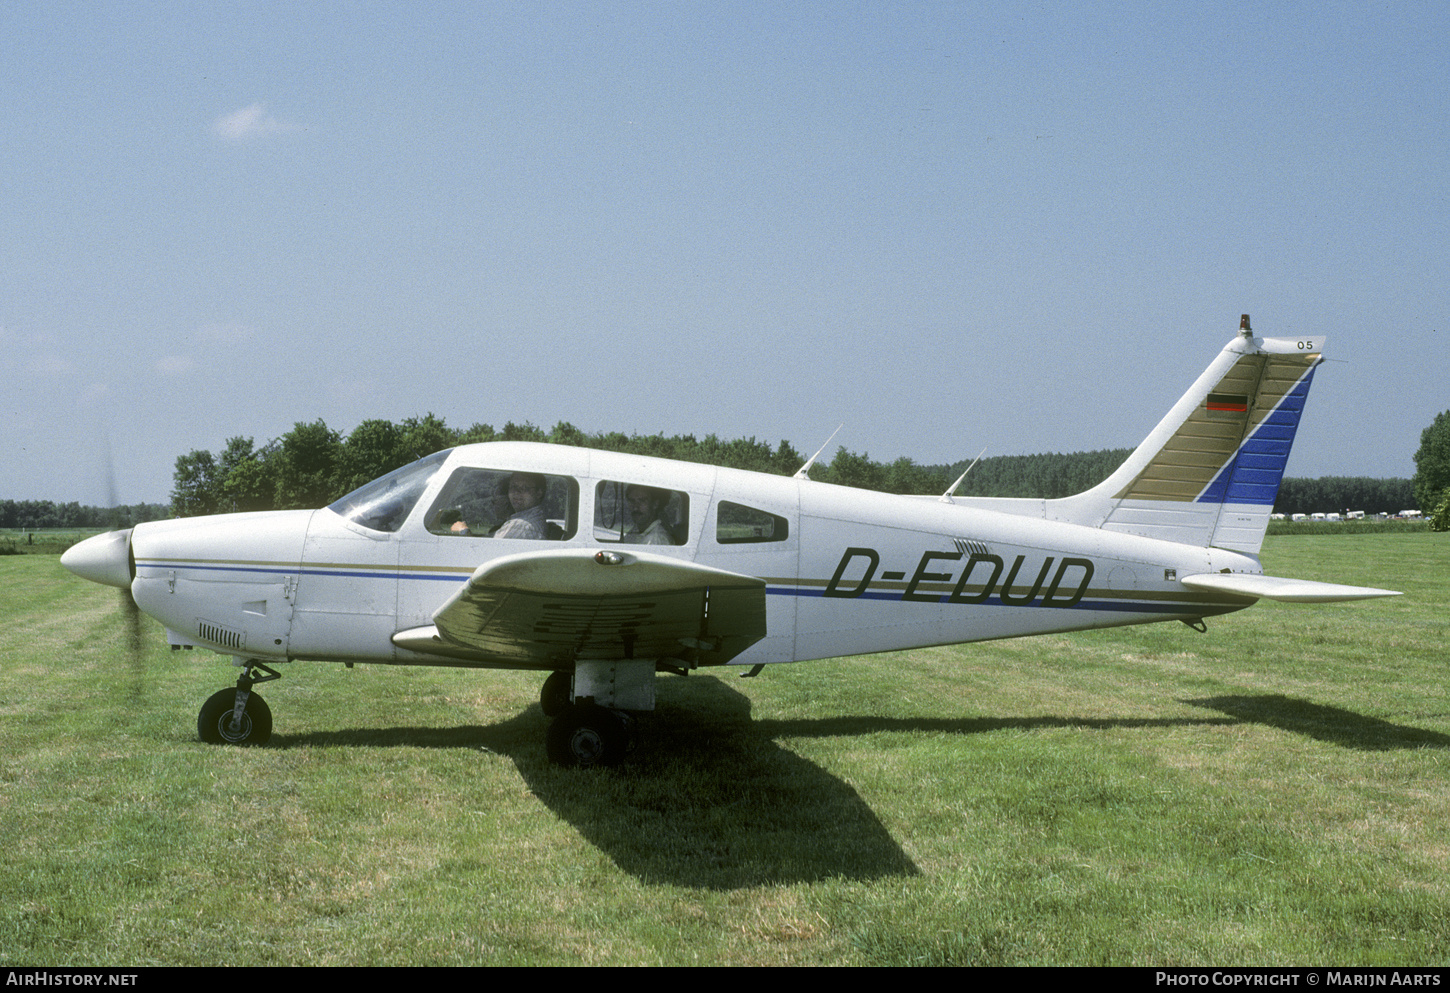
[0,533,1450,965]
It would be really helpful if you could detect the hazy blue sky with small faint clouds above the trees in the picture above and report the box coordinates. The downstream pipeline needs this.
[0,1,1450,503]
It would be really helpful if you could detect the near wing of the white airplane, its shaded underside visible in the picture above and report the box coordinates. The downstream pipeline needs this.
[393,549,766,668]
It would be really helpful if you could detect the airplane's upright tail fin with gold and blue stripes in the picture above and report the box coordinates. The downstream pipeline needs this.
[1047,316,1324,554]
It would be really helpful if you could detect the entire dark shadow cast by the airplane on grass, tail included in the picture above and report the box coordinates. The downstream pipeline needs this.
[273,676,1450,890]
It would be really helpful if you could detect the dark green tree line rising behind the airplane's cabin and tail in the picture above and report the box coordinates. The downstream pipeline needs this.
[161,413,1414,518]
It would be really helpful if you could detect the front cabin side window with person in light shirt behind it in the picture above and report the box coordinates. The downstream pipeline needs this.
[423,467,579,541]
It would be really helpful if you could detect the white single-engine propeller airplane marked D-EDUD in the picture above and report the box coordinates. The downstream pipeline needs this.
[61,316,1395,765]
